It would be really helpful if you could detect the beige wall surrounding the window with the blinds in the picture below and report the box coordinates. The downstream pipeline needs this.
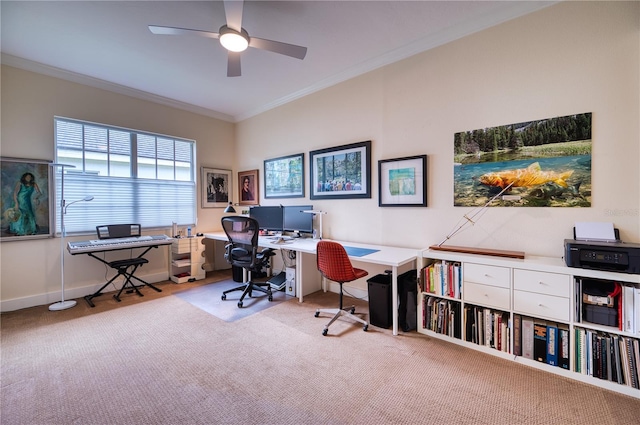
[0,65,235,311]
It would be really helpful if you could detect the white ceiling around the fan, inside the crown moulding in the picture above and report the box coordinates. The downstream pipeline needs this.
[0,0,555,121]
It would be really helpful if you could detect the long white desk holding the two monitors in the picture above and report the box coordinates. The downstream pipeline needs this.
[204,232,418,335]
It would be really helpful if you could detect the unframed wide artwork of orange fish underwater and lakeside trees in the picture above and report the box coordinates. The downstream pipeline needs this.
[453,113,591,207]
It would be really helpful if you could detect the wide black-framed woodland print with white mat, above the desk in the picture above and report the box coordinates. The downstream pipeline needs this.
[309,140,371,199]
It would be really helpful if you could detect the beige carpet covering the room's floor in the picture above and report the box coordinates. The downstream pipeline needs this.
[0,272,640,425]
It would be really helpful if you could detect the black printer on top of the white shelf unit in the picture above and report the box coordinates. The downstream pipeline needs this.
[564,239,640,274]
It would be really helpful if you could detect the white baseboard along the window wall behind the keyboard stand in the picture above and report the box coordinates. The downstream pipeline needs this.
[0,272,169,313]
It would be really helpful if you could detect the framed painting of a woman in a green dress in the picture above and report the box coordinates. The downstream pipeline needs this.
[0,158,52,242]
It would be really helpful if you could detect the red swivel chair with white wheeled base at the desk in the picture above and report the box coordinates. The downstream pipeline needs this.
[316,241,369,336]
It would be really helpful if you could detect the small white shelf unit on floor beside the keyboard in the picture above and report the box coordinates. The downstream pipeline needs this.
[170,236,206,283]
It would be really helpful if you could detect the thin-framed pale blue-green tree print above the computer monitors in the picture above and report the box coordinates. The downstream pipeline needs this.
[264,153,304,198]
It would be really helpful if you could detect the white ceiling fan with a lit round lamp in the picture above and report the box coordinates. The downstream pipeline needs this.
[149,0,307,77]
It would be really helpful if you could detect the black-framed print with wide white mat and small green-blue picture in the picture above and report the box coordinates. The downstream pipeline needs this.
[378,155,427,207]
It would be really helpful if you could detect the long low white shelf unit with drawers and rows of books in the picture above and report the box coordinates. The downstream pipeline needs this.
[417,249,640,398]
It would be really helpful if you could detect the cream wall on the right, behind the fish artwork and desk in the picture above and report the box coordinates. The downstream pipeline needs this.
[236,2,640,257]
